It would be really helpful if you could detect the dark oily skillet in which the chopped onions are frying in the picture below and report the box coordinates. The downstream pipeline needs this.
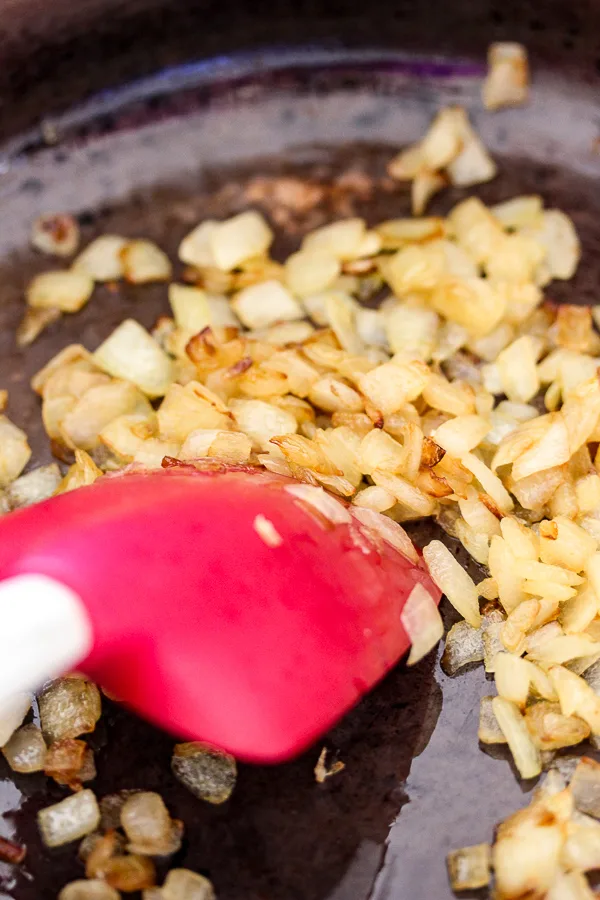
[0,0,600,900]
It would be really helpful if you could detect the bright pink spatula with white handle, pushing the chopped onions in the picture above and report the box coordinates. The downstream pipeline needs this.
[0,466,439,762]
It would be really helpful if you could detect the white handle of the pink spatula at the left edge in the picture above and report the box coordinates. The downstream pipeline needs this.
[0,574,93,710]
